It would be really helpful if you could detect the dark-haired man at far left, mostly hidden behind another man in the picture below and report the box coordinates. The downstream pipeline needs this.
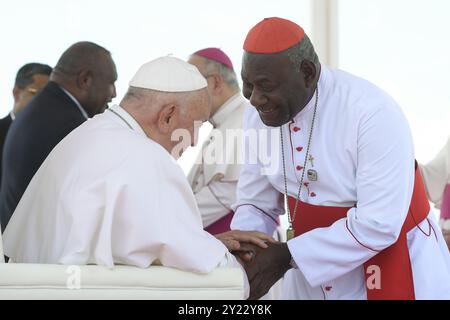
[0,63,52,184]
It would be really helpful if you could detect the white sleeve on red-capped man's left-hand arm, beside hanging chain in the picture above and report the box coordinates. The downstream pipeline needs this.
[231,110,284,235]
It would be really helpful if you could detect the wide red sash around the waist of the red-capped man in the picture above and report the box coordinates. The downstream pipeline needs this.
[288,163,430,300]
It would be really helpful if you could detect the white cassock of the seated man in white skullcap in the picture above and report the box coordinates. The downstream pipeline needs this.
[4,106,248,291]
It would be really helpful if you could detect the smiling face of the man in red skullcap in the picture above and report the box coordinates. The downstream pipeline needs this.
[241,53,312,127]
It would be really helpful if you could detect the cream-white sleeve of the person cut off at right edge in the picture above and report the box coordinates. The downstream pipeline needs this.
[420,139,450,208]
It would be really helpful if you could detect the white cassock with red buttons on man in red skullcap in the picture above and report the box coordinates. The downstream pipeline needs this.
[232,65,450,299]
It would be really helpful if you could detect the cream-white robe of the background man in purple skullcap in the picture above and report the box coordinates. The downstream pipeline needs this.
[188,93,249,228]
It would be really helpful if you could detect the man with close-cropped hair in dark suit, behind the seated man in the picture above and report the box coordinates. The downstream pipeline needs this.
[0,42,117,231]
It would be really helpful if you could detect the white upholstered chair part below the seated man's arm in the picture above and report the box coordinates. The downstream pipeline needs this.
[0,231,244,300]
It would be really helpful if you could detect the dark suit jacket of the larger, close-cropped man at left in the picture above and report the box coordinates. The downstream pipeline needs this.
[0,81,86,231]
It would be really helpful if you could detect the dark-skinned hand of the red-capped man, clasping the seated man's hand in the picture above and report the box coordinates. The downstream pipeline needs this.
[236,242,291,300]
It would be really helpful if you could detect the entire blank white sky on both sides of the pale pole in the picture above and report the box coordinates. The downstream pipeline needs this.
[0,0,450,171]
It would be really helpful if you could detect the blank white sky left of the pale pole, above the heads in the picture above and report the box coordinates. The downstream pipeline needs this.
[0,0,310,171]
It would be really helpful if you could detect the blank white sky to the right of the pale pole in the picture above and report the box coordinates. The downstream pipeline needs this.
[339,0,450,162]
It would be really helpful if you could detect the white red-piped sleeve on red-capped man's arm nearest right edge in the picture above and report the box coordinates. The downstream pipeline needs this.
[288,101,414,287]
